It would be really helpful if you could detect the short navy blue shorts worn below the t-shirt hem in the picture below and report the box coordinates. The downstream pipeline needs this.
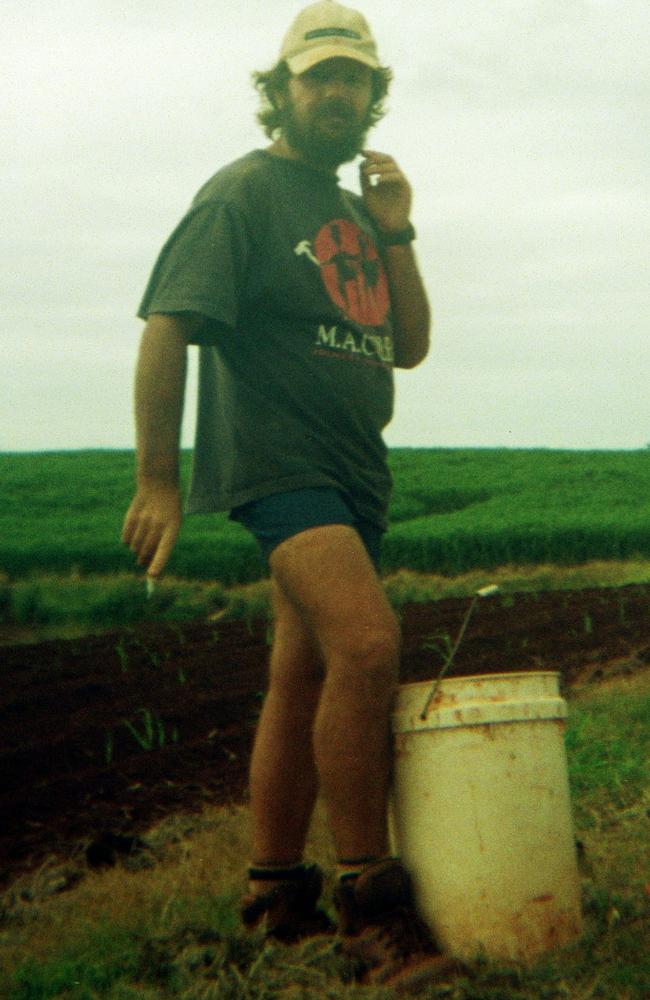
[230,486,384,571]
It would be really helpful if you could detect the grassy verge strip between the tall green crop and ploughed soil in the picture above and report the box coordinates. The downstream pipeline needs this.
[0,560,650,641]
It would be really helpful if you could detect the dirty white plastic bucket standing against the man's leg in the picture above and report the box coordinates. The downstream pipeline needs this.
[392,672,581,962]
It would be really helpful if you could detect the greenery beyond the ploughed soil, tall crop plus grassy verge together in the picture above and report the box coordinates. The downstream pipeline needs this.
[0,448,650,638]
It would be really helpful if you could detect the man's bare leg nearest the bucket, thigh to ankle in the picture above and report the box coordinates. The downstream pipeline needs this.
[271,525,399,859]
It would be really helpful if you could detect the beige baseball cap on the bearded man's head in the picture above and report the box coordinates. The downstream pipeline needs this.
[280,0,379,76]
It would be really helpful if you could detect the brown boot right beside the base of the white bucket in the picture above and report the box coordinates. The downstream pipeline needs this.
[335,859,462,992]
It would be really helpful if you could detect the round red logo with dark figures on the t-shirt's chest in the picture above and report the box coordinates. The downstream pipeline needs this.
[314,219,390,326]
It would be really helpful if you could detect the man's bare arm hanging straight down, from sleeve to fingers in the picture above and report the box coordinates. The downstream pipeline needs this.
[122,313,202,577]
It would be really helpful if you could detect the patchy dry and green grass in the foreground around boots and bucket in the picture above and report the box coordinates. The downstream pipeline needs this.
[0,672,650,1000]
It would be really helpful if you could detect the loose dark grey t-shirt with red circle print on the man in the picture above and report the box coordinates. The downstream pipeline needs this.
[138,150,393,526]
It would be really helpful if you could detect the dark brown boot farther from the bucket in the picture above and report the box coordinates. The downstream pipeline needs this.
[241,865,336,944]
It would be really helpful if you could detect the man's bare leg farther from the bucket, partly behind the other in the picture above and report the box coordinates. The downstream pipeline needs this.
[250,582,323,865]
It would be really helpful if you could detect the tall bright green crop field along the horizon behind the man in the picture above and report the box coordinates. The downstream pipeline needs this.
[0,449,650,586]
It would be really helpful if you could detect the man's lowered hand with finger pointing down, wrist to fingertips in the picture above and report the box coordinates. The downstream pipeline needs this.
[122,483,183,578]
